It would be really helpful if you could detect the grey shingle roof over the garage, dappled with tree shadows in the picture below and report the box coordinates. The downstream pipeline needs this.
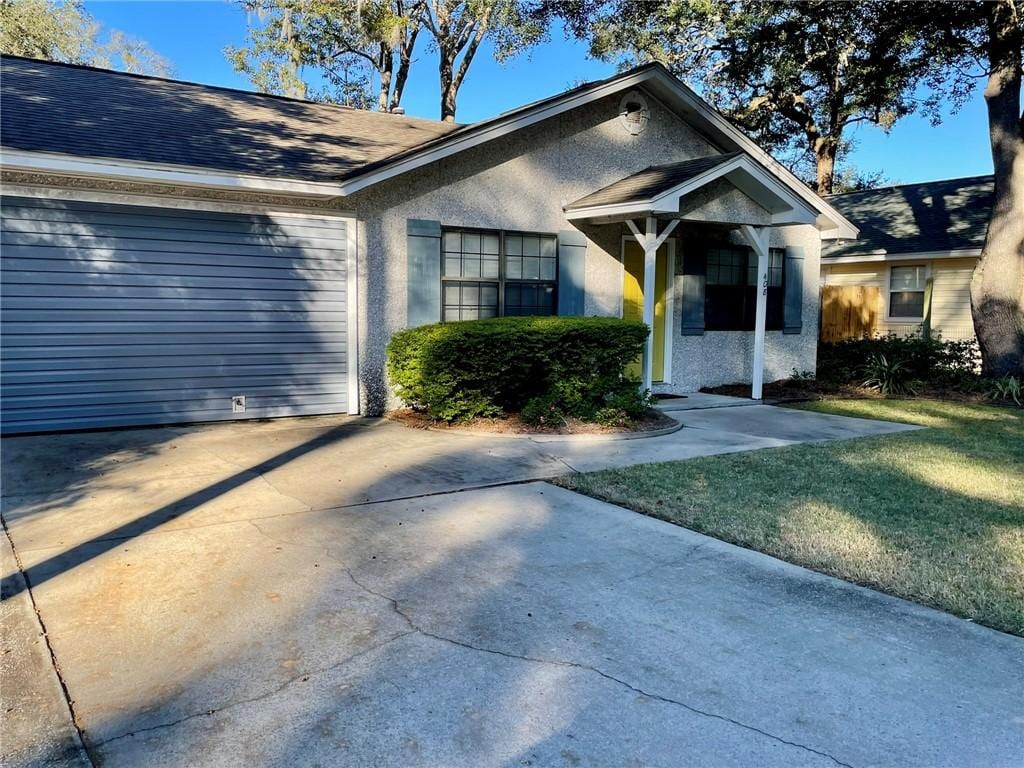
[0,56,459,181]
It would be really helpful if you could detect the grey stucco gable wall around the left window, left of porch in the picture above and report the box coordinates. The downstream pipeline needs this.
[344,88,718,413]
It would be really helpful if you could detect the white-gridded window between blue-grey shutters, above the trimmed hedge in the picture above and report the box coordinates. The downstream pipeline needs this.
[441,229,558,321]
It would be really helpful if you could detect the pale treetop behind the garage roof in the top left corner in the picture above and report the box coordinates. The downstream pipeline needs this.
[0,0,171,76]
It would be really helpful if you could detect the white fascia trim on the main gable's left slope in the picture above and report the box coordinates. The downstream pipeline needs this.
[333,72,650,195]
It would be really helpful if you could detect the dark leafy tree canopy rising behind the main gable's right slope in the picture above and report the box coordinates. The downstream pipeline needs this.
[548,0,970,194]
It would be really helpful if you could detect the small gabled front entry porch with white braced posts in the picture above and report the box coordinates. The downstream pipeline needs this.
[565,153,816,400]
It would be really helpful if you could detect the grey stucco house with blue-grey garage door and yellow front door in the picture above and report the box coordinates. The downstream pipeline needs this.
[0,56,857,433]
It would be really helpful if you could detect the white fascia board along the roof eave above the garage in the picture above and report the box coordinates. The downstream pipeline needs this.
[0,150,343,198]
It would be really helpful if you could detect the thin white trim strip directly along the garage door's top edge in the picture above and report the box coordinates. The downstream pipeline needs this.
[3,184,355,220]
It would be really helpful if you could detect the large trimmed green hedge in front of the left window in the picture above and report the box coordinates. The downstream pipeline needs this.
[387,317,649,424]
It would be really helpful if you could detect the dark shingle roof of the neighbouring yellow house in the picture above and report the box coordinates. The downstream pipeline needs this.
[821,176,992,257]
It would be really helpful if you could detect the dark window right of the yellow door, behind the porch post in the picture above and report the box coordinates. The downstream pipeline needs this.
[705,247,785,331]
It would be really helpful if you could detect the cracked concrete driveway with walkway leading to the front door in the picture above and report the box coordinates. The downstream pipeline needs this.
[0,407,1024,766]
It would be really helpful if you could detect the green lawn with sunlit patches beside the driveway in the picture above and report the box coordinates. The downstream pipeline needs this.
[560,400,1024,635]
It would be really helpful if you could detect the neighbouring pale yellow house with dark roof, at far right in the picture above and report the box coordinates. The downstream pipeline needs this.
[821,176,992,340]
